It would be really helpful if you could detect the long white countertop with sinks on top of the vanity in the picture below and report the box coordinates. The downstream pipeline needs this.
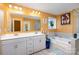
[0,32,44,40]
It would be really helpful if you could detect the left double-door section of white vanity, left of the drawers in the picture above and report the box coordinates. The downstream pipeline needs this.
[1,38,26,55]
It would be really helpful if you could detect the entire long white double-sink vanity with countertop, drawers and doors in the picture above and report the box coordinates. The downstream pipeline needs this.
[0,32,46,55]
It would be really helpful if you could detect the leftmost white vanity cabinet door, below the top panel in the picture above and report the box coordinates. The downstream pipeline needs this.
[1,43,15,55]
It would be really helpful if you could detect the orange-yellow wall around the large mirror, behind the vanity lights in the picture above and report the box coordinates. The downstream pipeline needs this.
[0,3,56,34]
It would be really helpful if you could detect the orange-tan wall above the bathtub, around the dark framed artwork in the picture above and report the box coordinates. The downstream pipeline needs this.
[56,11,76,33]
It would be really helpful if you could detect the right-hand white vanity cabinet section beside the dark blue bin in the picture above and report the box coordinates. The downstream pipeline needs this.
[34,35,46,52]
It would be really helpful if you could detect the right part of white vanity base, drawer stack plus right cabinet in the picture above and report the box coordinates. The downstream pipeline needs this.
[27,35,46,54]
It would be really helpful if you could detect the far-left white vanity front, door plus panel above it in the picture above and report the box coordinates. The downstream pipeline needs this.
[1,40,16,55]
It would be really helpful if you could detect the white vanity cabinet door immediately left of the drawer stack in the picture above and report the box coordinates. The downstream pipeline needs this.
[15,40,26,55]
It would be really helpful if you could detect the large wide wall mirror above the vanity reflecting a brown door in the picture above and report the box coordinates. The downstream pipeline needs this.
[8,14,41,32]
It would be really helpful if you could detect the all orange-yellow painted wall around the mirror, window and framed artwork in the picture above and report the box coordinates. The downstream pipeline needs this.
[0,4,76,34]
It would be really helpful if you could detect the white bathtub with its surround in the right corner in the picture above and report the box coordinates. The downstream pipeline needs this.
[50,37,74,54]
